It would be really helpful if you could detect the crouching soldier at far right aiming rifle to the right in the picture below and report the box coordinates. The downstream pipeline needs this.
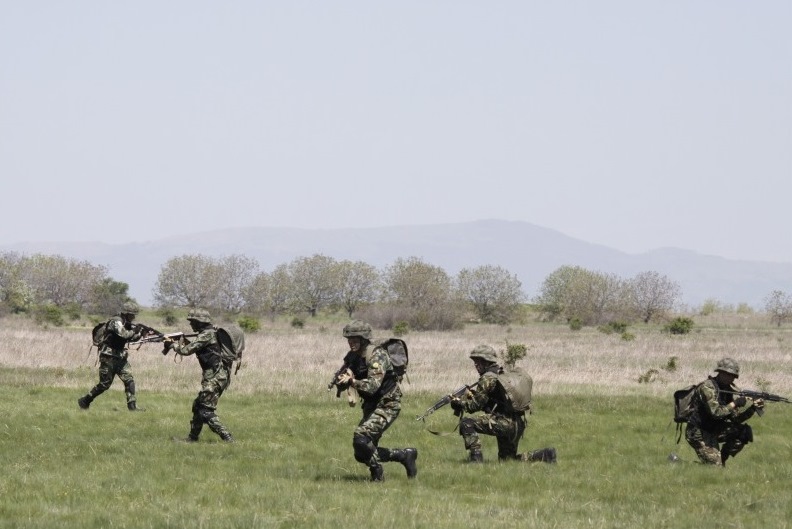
[685,358,764,465]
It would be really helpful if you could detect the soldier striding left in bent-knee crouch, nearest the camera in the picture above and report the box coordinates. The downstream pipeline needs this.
[338,321,418,481]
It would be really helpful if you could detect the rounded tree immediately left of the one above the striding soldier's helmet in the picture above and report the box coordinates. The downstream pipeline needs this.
[288,254,339,317]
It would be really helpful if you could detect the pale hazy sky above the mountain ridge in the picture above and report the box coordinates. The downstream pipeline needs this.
[0,0,792,262]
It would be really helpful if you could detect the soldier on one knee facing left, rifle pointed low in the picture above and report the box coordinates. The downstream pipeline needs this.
[450,345,556,463]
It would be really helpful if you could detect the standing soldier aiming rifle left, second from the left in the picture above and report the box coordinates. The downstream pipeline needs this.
[165,309,234,443]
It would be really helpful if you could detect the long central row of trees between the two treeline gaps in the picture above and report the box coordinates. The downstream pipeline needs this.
[153,254,525,329]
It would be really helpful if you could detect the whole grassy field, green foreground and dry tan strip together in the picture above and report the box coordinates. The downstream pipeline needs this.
[0,319,792,529]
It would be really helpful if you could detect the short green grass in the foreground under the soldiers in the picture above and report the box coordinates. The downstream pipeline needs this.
[0,368,792,529]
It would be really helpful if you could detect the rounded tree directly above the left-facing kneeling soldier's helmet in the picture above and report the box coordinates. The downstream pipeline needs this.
[456,265,525,323]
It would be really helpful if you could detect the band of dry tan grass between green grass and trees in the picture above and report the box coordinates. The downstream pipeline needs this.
[0,316,792,398]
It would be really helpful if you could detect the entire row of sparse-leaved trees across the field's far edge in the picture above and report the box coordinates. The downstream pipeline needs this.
[7,252,792,330]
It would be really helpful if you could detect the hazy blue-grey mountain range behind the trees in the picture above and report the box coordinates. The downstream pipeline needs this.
[0,220,792,308]
